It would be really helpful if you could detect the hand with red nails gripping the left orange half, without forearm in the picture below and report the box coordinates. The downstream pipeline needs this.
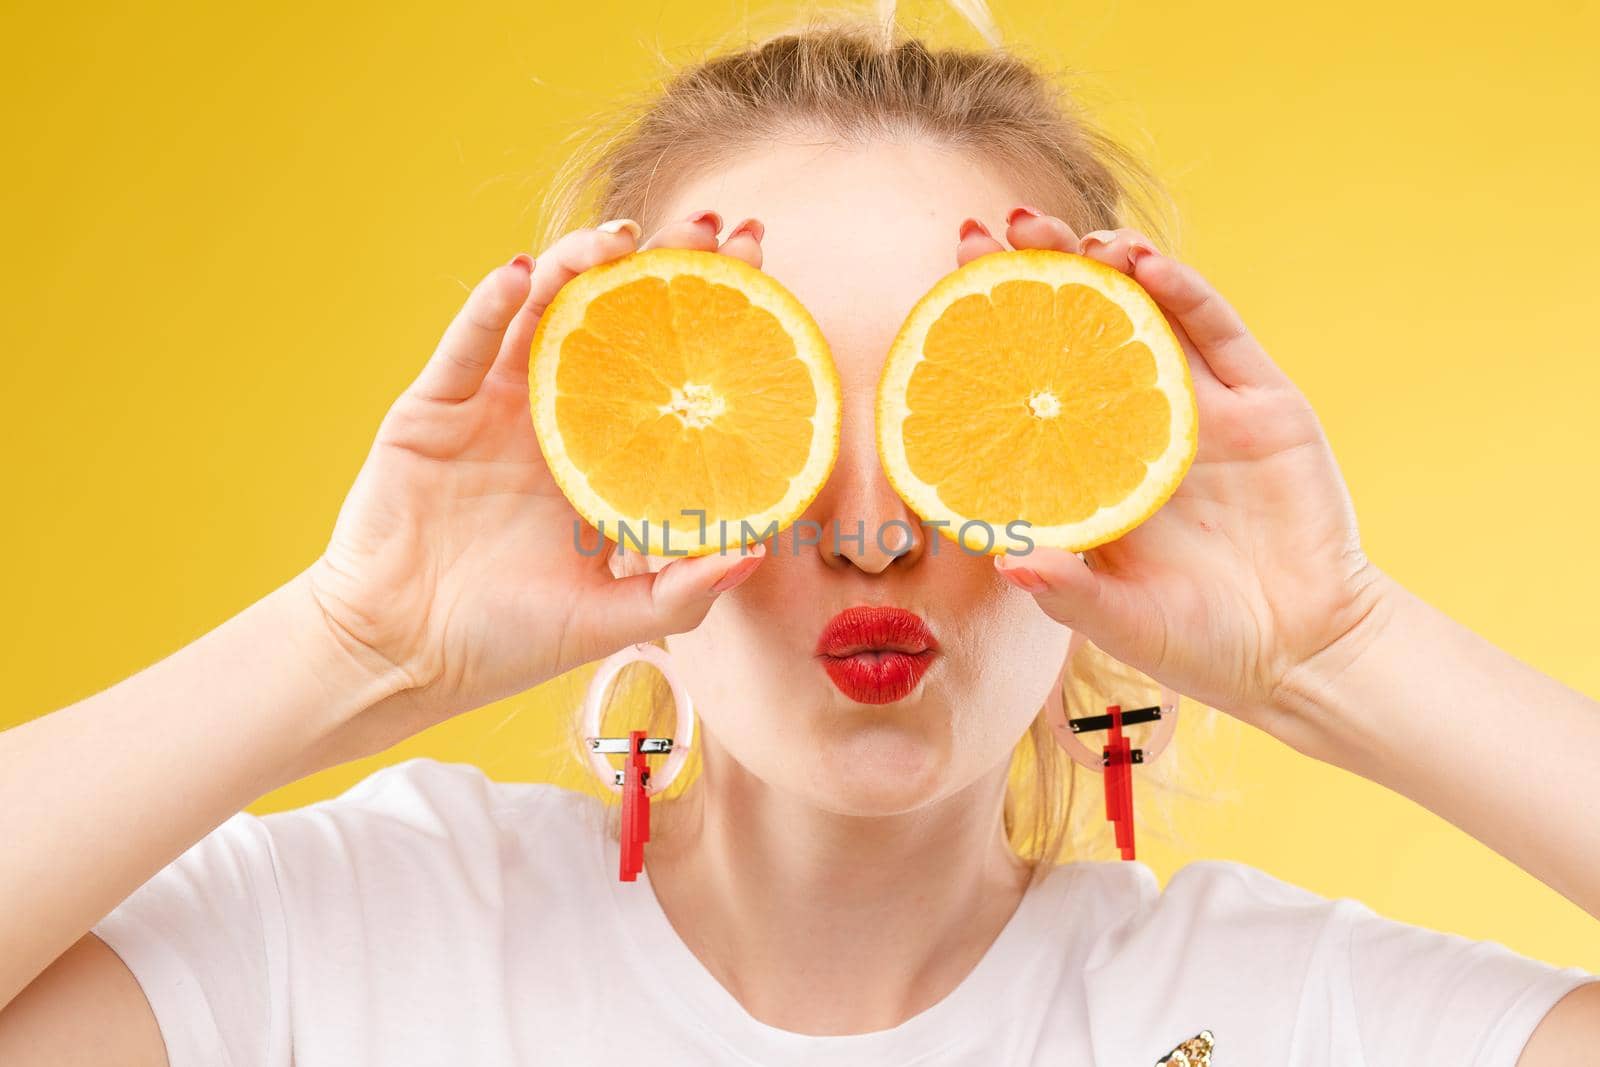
[304,211,762,757]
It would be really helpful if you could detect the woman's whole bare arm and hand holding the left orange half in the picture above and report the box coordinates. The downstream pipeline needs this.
[0,211,760,1067]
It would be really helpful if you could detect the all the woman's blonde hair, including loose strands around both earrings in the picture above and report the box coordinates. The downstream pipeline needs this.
[534,0,1192,877]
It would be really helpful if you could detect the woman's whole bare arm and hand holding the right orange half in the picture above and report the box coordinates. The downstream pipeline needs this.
[963,219,1600,1067]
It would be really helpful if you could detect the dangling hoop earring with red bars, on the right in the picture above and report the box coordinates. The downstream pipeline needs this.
[1045,630,1178,859]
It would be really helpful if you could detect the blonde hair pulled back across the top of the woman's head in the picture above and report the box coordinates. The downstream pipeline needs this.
[534,0,1178,251]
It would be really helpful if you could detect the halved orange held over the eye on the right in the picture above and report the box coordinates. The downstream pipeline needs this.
[877,250,1200,553]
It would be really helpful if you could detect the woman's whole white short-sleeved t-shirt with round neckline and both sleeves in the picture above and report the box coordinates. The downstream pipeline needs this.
[94,758,1600,1067]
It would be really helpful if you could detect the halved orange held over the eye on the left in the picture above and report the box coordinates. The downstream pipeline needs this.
[528,248,840,555]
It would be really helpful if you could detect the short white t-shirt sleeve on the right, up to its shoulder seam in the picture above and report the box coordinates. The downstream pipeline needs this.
[1342,901,1600,1067]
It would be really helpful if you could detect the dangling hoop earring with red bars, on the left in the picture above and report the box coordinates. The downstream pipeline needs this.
[584,645,694,881]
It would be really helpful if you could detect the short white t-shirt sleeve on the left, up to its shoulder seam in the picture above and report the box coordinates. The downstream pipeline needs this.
[91,811,290,1067]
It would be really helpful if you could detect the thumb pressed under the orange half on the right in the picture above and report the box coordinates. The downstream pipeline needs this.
[995,547,1160,664]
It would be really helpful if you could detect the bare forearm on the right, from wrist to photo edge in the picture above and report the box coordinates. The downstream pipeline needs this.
[1274,576,1600,918]
